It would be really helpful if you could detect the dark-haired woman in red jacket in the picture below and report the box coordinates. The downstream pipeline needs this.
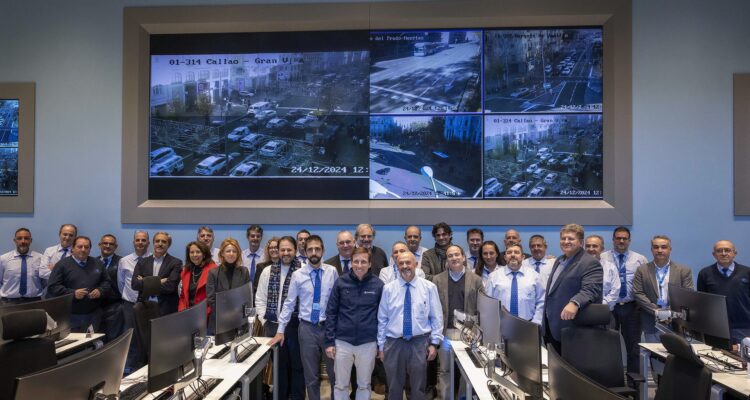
[177,241,216,317]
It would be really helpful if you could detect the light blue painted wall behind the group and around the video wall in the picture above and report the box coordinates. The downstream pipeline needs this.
[0,0,750,271]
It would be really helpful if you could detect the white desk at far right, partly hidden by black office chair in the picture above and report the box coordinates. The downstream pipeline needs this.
[638,343,750,400]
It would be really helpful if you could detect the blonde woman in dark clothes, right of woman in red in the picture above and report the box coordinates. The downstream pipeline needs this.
[206,238,250,332]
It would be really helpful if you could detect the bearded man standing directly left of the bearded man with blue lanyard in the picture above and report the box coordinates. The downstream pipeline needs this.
[255,236,305,400]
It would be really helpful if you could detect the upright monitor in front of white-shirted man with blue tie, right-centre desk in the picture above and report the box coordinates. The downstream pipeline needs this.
[500,307,543,399]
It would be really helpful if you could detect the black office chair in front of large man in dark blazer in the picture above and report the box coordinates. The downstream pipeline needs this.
[561,304,644,398]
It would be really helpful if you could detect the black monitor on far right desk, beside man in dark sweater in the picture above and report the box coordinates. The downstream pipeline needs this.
[669,283,731,348]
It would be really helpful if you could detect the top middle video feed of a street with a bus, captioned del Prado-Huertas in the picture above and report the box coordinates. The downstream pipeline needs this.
[369,30,482,114]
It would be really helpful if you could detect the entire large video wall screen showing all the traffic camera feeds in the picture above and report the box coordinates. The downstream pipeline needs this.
[148,27,603,200]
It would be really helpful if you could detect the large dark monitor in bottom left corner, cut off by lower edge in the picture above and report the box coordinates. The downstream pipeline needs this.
[12,329,133,400]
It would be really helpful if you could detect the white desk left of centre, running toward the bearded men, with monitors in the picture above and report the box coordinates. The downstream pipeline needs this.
[120,337,278,400]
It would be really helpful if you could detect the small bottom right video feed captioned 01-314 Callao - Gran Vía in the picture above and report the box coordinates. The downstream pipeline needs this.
[484,114,602,199]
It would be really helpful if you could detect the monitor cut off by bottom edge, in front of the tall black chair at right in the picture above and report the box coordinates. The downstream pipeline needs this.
[547,346,625,400]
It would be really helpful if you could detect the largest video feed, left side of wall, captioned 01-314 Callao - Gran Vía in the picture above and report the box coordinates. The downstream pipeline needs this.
[149,51,369,178]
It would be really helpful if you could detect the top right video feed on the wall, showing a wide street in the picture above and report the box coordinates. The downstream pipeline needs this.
[484,28,602,113]
